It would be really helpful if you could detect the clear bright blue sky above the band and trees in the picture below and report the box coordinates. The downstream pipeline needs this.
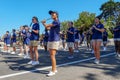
[0,0,119,35]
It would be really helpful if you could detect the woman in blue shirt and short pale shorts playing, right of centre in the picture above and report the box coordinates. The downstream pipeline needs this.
[92,18,104,64]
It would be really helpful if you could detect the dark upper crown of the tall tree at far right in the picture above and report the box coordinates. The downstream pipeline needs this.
[99,0,120,22]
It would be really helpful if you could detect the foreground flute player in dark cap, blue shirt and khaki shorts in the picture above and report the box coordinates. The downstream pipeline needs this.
[42,11,60,76]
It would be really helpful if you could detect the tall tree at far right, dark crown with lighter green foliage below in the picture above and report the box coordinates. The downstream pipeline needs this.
[99,0,120,38]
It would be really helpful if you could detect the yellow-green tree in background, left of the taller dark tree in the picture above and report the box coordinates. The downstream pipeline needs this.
[61,12,95,32]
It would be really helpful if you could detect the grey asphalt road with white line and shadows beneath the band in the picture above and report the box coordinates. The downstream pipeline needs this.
[0,46,120,80]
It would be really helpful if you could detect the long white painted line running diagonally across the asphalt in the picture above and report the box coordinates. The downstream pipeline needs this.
[0,53,115,79]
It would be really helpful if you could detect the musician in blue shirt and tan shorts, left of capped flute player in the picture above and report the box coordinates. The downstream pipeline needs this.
[28,17,40,65]
